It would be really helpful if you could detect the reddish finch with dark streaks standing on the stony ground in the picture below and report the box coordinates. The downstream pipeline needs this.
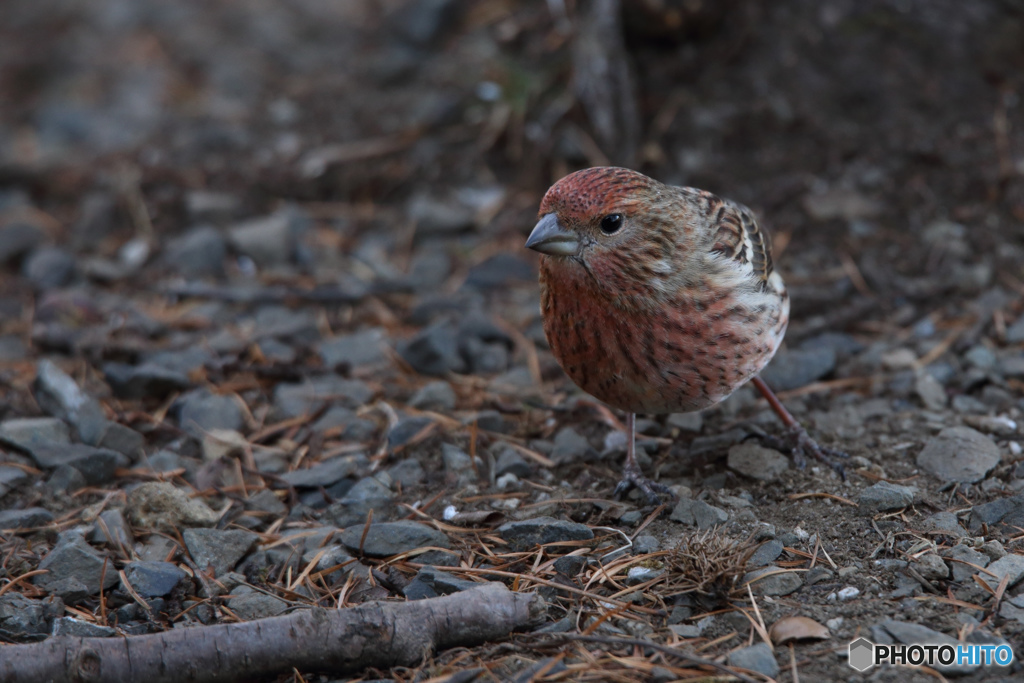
[525,166,846,504]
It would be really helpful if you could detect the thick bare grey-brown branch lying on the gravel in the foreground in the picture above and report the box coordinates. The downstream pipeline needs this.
[0,583,544,683]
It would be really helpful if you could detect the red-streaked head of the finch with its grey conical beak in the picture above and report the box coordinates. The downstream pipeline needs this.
[526,167,694,299]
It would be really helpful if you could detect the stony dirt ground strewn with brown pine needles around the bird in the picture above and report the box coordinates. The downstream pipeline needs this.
[0,0,1024,682]
